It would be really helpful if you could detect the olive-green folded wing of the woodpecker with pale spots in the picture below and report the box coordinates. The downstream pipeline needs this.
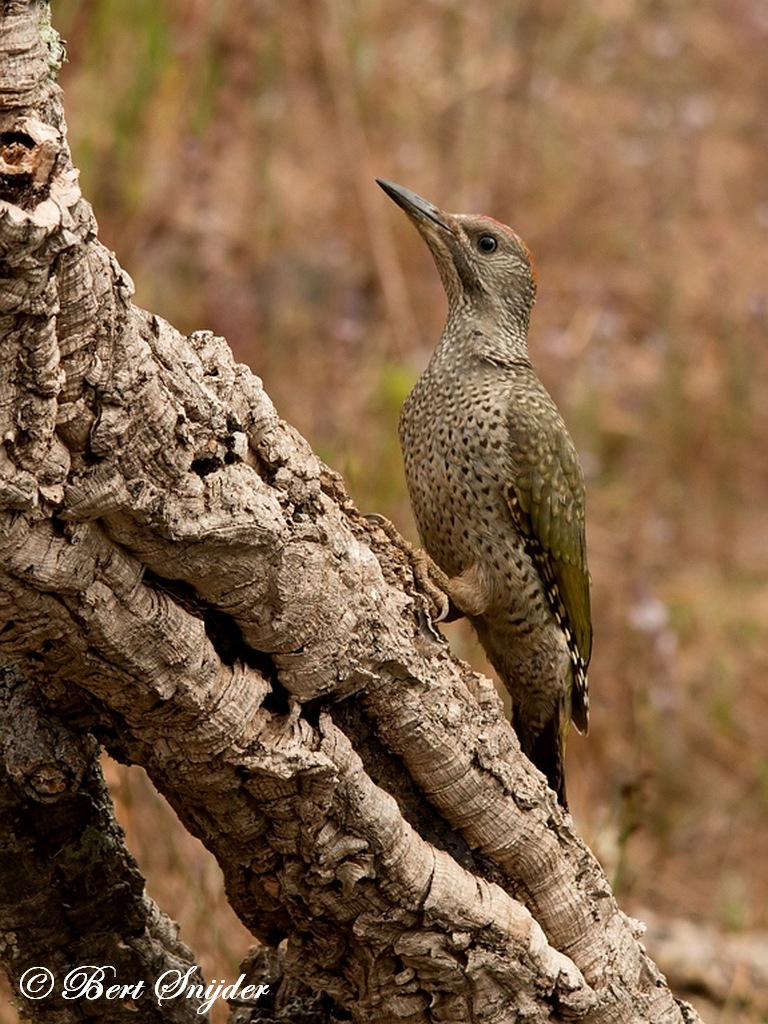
[508,396,592,670]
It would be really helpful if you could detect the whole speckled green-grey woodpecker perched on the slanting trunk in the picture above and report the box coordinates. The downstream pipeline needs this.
[380,182,592,806]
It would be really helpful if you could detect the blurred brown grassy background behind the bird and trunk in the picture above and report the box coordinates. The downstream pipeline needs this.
[10,0,768,1020]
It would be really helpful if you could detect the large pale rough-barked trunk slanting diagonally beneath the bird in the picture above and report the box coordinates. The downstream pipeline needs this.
[0,3,708,1024]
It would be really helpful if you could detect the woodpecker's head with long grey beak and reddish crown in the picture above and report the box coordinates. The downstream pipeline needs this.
[376,178,537,338]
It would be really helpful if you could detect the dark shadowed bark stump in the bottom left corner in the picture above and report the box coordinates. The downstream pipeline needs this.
[0,669,205,1024]
